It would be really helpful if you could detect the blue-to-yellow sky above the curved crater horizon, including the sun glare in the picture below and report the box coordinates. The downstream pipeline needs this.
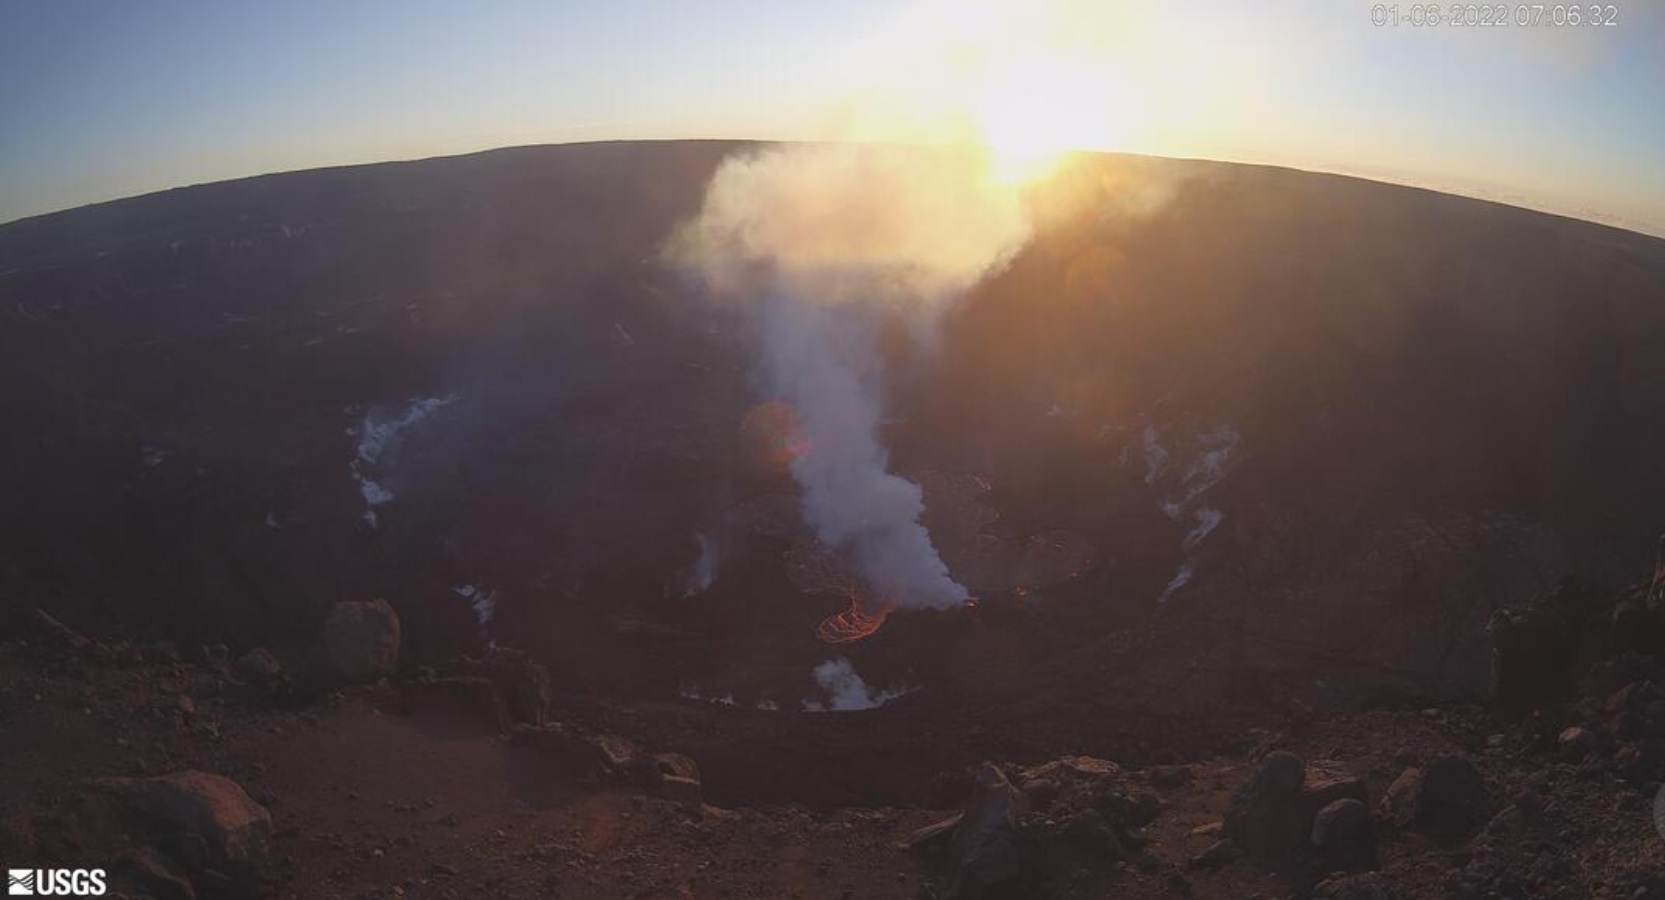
[0,0,1665,235]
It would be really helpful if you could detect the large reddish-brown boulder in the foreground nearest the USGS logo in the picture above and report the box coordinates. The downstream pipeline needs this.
[95,770,271,883]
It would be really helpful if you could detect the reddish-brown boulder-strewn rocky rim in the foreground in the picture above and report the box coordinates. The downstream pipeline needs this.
[0,587,1665,900]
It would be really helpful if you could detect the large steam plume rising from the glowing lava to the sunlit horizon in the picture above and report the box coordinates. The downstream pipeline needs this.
[668,145,1031,609]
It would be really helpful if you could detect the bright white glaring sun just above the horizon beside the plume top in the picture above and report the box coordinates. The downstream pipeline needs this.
[972,55,1142,183]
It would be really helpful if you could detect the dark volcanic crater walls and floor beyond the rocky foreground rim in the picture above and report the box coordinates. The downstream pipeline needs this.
[0,143,1665,709]
